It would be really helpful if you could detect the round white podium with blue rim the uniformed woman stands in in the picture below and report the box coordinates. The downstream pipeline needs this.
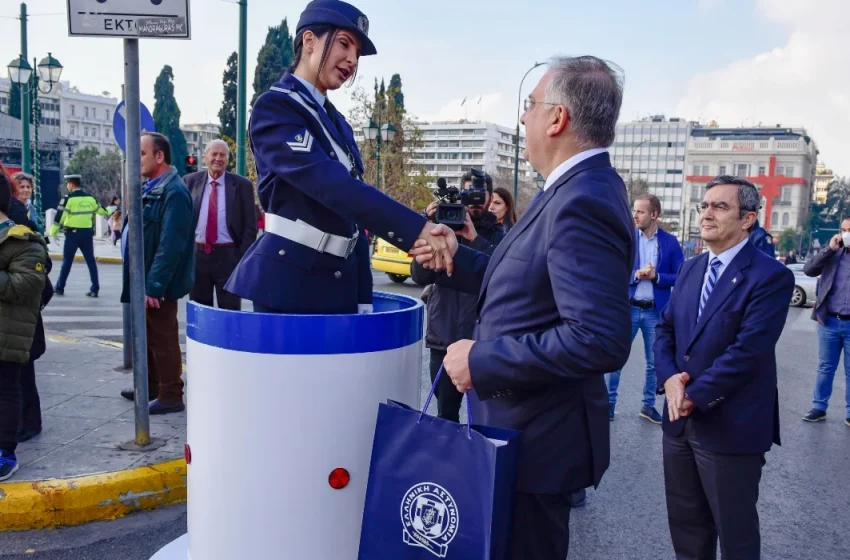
[152,293,424,560]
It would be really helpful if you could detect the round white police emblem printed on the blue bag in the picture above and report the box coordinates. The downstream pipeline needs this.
[401,482,458,558]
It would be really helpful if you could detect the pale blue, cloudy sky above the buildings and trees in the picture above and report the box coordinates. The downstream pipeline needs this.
[0,0,850,174]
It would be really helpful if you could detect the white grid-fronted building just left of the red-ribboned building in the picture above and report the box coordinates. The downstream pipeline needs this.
[608,115,693,235]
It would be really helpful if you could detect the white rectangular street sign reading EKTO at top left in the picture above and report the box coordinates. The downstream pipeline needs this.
[68,0,191,39]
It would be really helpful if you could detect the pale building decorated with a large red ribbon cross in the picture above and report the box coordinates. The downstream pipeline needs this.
[681,125,818,240]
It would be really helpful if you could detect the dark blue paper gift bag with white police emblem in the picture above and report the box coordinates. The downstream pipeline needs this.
[358,368,520,560]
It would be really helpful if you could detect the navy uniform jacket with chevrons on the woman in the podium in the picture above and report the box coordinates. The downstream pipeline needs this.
[225,73,426,313]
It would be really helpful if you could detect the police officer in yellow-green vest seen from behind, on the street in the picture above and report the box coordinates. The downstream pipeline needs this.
[50,175,109,297]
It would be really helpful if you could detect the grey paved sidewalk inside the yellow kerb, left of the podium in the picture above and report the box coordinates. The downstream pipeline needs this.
[9,333,186,482]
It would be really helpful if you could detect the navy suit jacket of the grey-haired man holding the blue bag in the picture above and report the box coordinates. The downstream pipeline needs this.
[437,153,635,494]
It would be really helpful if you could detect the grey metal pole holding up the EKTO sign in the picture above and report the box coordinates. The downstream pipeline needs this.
[122,39,151,447]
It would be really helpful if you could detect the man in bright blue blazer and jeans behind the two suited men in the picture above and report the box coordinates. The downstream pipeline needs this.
[606,193,685,424]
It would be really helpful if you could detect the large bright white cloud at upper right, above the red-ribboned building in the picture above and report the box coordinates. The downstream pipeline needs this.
[677,0,850,174]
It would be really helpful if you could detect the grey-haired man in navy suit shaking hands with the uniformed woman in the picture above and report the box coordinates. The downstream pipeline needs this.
[414,56,634,560]
